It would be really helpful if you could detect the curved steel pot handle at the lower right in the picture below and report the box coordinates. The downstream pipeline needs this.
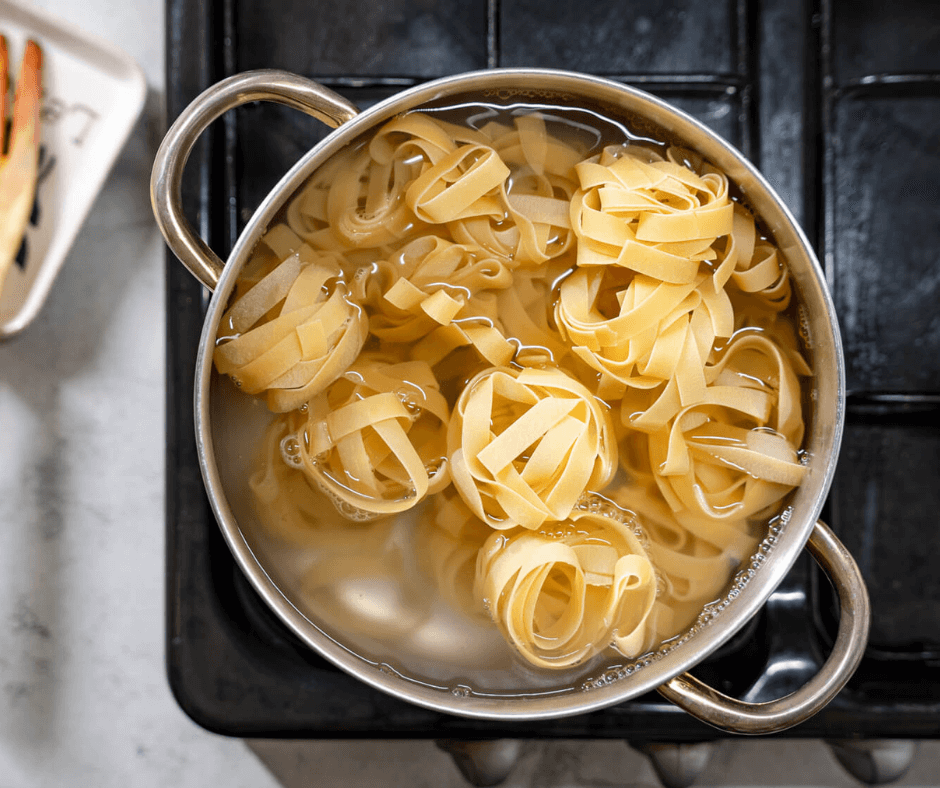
[659,520,871,734]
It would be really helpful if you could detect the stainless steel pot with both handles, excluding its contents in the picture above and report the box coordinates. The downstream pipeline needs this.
[151,69,870,733]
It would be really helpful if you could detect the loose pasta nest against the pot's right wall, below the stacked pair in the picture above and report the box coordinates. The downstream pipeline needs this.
[621,331,809,528]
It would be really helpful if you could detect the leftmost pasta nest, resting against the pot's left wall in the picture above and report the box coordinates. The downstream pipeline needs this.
[213,225,369,413]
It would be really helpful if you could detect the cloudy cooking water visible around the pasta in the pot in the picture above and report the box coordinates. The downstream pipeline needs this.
[211,97,808,695]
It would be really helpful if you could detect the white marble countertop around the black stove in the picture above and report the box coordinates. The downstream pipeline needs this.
[0,0,940,788]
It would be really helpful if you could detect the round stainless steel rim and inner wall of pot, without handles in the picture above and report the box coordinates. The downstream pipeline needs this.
[194,68,845,721]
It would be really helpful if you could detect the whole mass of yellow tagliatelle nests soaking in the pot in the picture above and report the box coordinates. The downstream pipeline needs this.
[215,104,810,668]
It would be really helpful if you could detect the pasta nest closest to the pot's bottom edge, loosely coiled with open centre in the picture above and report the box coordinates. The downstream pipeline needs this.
[476,511,656,669]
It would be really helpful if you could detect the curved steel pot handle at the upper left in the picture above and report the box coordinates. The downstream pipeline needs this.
[150,69,359,290]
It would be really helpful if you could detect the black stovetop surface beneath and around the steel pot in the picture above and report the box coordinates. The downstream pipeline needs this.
[167,0,940,741]
